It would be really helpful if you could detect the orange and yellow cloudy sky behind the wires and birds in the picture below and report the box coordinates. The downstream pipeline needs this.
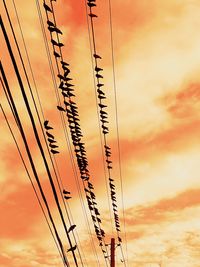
[0,0,200,267]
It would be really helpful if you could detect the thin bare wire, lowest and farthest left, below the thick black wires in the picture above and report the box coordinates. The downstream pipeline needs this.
[0,102,65,266]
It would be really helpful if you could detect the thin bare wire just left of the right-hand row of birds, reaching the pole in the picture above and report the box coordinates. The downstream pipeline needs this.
[85,0,113,237]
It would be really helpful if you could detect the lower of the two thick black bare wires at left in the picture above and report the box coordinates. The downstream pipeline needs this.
[0,59,69,266]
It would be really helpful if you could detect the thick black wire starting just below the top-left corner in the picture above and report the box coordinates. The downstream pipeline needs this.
[1,19,78,266]
